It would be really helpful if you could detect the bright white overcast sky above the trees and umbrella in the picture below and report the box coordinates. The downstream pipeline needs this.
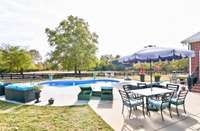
[0,0,200,57]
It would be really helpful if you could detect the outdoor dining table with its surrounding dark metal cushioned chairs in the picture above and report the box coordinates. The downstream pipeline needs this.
[119,83,188,120]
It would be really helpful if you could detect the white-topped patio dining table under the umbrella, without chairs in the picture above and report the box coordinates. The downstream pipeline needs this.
[132,87,174,114]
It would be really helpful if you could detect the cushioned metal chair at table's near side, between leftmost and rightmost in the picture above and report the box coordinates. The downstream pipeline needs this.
[148,93,173,120]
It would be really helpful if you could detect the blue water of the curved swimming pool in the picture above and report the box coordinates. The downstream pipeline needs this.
[40,79,119,87]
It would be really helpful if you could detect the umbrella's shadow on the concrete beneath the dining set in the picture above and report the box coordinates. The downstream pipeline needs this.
[121,110,198,131]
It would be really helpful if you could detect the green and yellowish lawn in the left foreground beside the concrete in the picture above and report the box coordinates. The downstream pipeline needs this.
[0,101,113,131]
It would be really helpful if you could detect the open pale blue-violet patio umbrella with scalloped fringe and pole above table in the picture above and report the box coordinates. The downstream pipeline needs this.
[119,45,194,83]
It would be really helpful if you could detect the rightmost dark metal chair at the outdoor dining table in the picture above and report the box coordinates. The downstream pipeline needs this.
[170,90,188,116]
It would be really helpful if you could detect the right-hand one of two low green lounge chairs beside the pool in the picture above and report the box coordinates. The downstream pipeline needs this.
[101,86,113,100]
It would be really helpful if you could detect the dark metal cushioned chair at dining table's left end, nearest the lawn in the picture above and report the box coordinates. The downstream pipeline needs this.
[119,90,145,119]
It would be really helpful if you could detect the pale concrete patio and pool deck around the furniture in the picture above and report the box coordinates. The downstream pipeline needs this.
[0,81,200,131]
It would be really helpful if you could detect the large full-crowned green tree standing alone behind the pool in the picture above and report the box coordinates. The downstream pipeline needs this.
[45,16,98,74]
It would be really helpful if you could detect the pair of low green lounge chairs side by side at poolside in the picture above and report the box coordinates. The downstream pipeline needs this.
[78,84,113,100]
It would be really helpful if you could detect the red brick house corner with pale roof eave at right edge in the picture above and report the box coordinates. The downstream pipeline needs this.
[181,32,200,92]
